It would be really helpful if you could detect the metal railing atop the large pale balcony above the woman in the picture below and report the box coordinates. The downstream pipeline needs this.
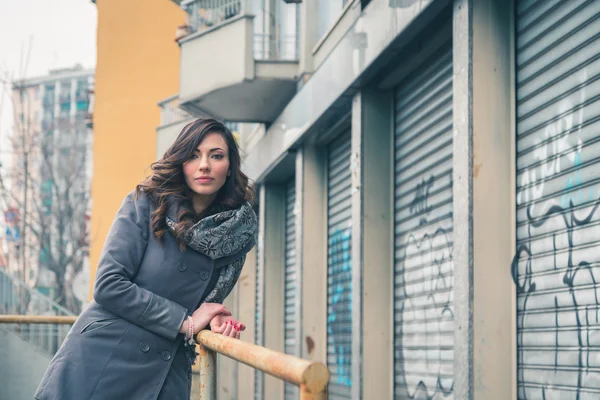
[181,0,299,61]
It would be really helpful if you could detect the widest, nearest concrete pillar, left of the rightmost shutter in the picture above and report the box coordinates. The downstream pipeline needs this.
[453,0,516,400]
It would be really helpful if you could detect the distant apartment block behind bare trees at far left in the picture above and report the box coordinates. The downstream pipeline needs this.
[9,65,94,312]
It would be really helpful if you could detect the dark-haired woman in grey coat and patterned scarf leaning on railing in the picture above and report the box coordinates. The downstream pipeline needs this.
[35,119,257,400]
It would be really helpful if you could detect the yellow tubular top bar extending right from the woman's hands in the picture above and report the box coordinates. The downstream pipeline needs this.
[197,331,329,398]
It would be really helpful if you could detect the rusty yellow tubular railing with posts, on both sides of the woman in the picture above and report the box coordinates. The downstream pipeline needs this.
[0,315,329,400]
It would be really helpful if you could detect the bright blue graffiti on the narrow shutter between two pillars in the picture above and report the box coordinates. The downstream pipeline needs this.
[327,228,352,387]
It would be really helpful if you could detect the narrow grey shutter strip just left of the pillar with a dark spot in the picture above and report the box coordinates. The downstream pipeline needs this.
[284,180,299,400]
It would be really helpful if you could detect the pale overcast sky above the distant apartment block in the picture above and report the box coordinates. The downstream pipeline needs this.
[0,0,96,155]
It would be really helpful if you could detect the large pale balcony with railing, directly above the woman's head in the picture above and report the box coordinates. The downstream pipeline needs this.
[178,0,299,123]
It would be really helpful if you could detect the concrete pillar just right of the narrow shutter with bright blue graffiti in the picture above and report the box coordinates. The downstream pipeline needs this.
[352,88,394,399]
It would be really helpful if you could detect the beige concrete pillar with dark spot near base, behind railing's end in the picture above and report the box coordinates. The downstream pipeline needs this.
[300,144,327,363]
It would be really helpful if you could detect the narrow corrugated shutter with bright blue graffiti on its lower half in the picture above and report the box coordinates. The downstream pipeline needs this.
[327,132,352,400]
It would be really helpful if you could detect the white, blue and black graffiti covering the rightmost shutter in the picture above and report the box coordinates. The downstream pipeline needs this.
[511,69,600,399]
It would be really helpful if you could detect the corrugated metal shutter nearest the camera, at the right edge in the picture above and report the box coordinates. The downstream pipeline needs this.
[512,0,600,399]
